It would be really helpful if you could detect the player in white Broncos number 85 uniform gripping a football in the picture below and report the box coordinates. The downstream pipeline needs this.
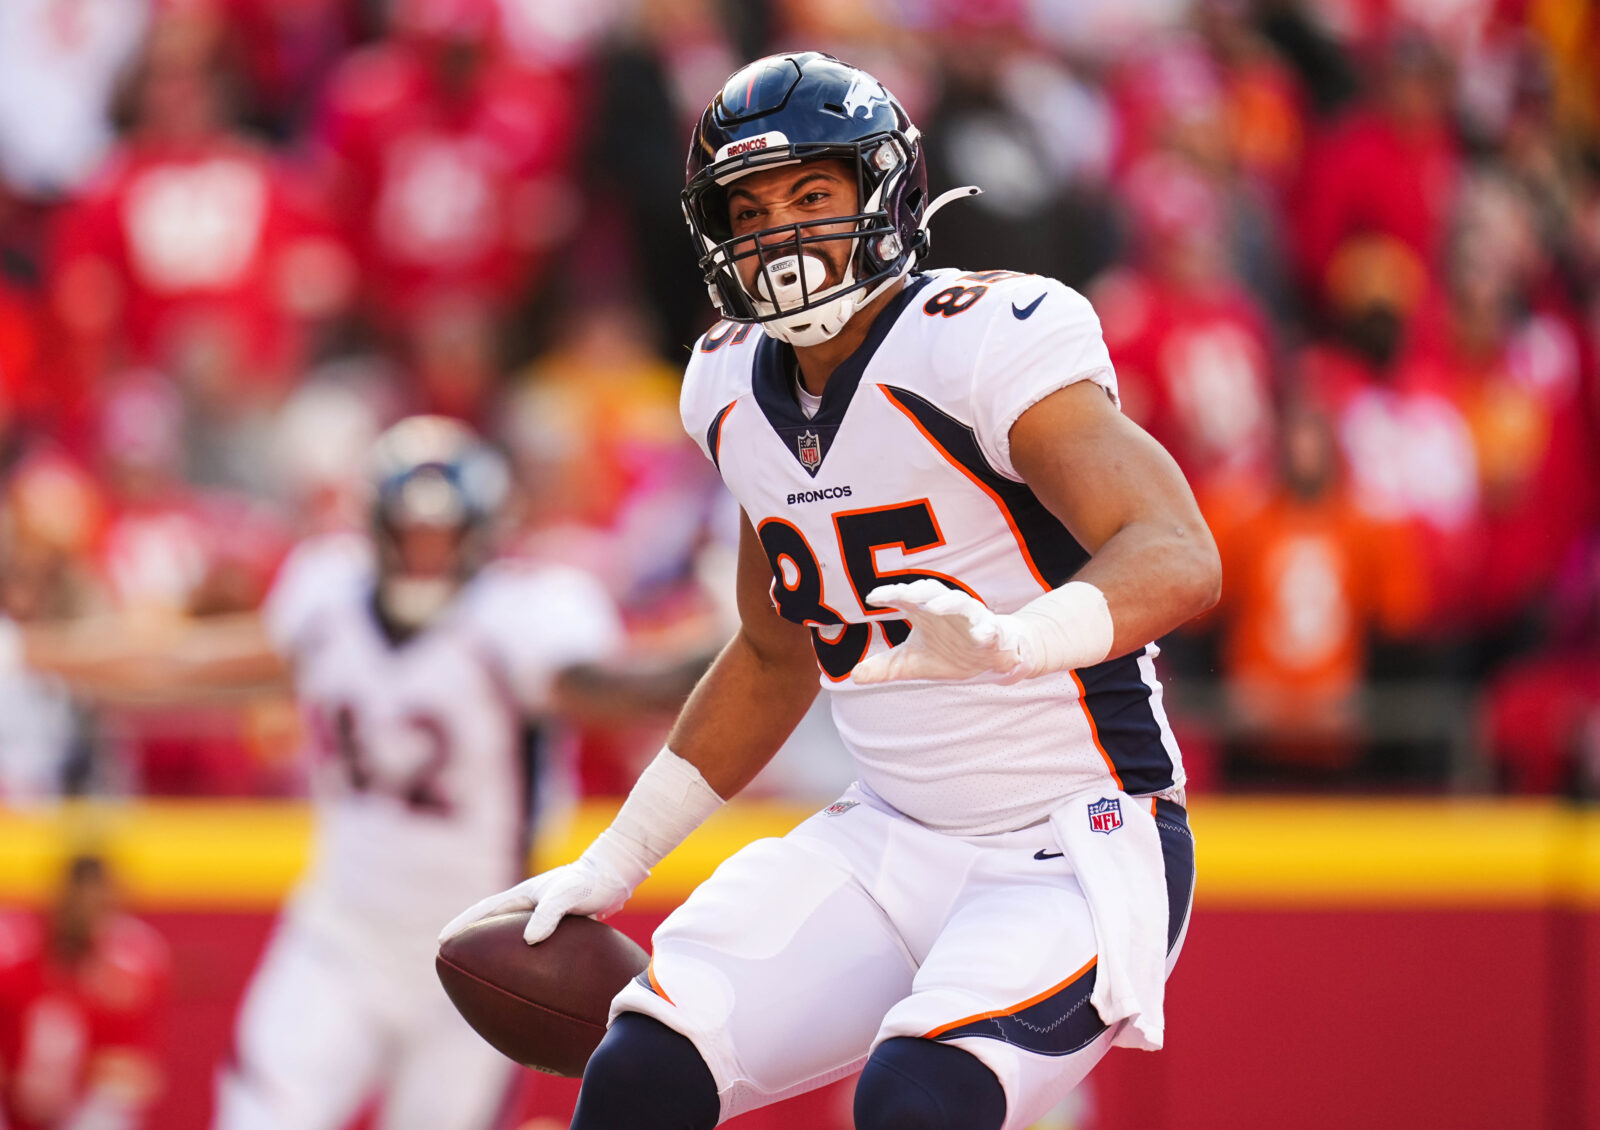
[445,53,1221,1130]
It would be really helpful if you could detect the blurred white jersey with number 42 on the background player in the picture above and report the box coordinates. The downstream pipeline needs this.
[262,535,622,946]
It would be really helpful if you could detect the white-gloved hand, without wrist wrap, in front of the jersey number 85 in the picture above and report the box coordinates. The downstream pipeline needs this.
[851,578,1022,683]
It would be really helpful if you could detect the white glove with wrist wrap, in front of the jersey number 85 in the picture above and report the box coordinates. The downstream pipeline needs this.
[851,578,1114,683]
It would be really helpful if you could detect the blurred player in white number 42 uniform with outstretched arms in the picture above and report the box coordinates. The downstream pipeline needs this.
[29,416,640,1130]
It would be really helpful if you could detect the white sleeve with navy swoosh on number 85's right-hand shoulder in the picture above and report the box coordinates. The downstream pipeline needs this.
[971,278,1122,482]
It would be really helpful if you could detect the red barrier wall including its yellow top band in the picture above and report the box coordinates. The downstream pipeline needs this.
[9,799,1600,1130]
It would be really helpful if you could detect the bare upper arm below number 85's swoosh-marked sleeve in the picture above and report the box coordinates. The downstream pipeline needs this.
[1011,381,1211,554]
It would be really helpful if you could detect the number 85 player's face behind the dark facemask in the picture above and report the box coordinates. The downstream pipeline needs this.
[728,160,859,291]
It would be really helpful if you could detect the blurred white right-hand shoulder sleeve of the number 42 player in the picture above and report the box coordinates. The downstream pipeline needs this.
[472,565,624,714]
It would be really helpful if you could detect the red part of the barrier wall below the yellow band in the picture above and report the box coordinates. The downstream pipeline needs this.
[134,908,1600,1130]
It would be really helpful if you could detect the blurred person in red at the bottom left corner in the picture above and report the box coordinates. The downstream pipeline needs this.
[0,855,170,1130]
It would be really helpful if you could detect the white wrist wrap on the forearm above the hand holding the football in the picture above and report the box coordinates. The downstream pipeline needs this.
[584,746,723,887]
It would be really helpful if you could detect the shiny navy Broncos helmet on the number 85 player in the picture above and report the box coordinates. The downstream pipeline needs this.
[683,51,978,346]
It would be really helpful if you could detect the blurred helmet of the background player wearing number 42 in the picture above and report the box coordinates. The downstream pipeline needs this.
[370,416,510,629]
